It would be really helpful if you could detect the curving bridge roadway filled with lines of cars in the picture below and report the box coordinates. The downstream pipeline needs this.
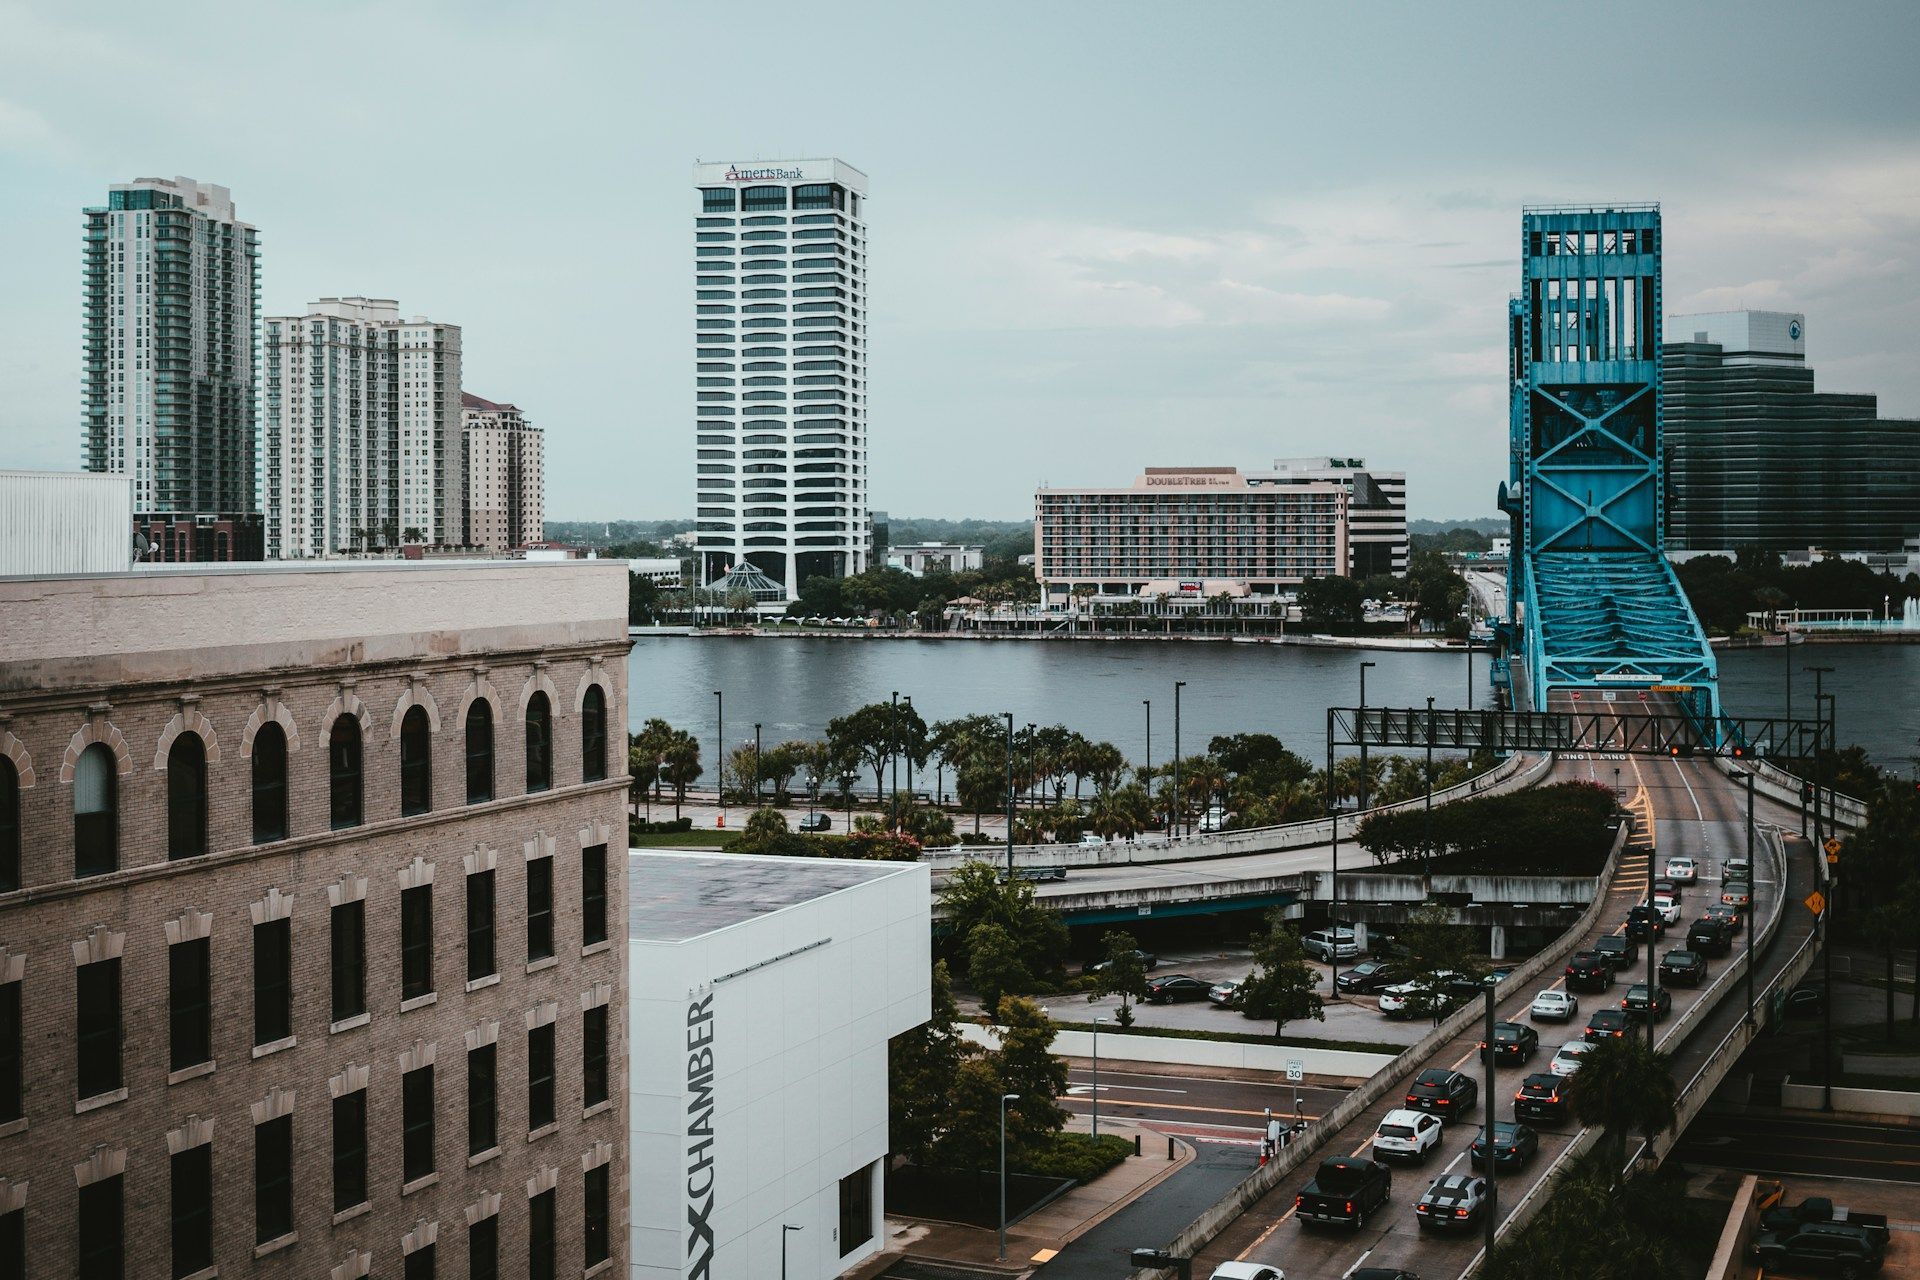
[1194,758,1814,1280]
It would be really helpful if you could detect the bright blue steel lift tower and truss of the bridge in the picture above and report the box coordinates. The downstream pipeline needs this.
[1500,205,1720,735]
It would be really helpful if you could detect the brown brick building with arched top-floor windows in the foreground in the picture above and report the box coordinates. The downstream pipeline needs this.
[0,560,628,1280]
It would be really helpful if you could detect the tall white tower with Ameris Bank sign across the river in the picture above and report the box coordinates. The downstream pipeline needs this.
[693,159,872,599]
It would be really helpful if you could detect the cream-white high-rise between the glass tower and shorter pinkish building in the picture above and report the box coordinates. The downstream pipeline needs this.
[261,297,467,560]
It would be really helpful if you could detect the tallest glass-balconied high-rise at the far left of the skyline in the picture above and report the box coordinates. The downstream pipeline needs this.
[83,178,259,516]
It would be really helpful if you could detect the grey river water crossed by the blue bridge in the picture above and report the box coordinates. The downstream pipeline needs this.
[628,635,1920,781]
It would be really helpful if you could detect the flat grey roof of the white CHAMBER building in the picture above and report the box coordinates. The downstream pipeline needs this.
[626,848,920,942]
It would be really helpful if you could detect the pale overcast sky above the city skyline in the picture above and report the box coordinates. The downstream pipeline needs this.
[0,0,1920,520]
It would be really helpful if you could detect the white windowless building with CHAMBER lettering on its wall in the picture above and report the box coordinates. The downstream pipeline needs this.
[628,850,931,1280]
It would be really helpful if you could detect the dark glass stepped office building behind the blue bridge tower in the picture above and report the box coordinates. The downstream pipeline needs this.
[1661,311,1920,553]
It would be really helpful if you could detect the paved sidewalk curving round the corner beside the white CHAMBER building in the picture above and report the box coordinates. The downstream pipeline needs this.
[847,1117,1194,1280]
